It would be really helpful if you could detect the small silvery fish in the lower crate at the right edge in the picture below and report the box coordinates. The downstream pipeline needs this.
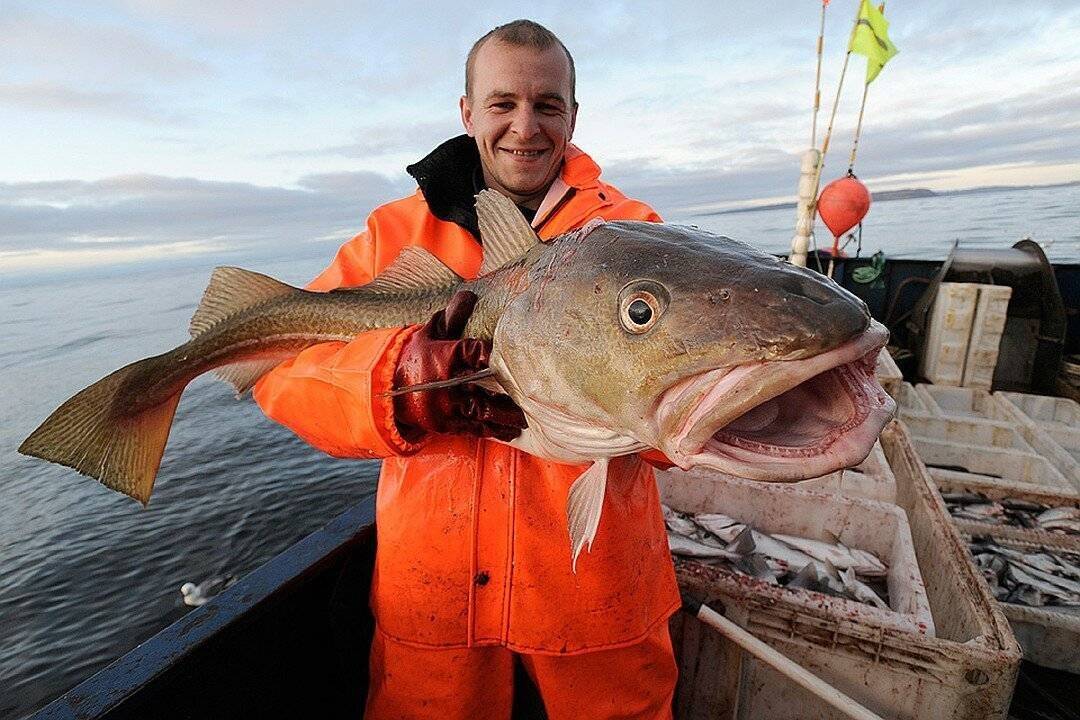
[969,536,1080,612]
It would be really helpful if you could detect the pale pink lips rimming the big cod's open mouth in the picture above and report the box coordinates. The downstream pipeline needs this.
[658,322,896,481]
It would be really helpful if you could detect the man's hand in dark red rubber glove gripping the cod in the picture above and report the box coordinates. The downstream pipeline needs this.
[394,290,527,443]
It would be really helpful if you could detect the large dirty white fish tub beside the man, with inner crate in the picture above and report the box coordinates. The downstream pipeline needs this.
[658,422,1021,719]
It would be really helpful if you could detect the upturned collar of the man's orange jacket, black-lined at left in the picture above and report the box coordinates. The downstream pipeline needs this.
[405,135,600,240]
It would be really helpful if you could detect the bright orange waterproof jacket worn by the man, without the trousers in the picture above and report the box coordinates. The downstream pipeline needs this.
[255,139,679,654]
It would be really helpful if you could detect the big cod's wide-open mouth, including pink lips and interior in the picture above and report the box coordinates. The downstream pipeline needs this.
[659,322,896,481]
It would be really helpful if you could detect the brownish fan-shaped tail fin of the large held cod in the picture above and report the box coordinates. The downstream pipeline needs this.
[18,357,184,505]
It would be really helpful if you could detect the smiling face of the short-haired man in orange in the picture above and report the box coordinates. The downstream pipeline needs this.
[461,40,578,209]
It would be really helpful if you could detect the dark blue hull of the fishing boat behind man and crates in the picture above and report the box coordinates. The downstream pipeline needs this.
[29,246,1080,720]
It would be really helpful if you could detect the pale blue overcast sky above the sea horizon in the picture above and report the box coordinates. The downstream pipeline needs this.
[0,0,1080,274]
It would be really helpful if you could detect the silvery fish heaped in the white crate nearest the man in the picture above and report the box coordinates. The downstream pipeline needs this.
[663,505,889,610]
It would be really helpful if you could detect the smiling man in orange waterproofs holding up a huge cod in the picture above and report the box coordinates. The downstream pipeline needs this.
[255,21,679,720]
